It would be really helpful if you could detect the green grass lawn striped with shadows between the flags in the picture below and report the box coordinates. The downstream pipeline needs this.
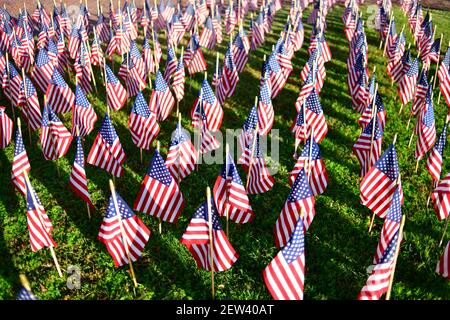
[0,6,450,299]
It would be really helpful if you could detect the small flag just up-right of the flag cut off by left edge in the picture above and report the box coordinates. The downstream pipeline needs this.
[17,76,42,131]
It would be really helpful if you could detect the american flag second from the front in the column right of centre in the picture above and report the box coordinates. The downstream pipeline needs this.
[274,169,316,248]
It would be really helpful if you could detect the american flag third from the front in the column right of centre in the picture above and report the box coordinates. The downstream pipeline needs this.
[289,137,328,196]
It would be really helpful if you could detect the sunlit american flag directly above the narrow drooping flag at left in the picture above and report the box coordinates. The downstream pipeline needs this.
[72,85,97,137]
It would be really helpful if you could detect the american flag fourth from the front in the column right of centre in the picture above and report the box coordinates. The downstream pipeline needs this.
[304,89,328,143]
